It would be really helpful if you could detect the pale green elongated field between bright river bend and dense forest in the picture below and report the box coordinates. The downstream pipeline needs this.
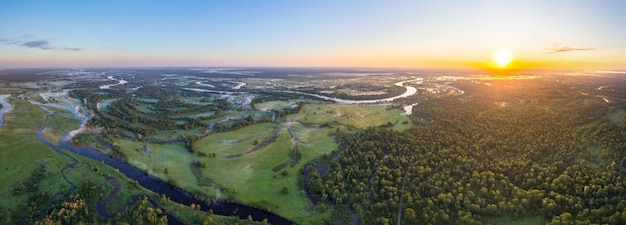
[287,104,410,129]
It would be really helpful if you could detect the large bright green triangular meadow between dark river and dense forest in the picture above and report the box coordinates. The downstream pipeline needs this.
[194,128,319,224]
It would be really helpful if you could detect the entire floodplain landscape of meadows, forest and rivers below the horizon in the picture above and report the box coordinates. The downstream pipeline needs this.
[0,68,626,224]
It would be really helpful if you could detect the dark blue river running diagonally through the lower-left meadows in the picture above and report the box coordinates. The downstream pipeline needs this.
[30,100,294,224]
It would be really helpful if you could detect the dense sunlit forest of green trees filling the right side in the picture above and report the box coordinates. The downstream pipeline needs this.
[308,78,626,224]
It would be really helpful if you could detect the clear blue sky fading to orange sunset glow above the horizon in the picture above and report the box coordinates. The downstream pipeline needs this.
[0,0,626,70]
